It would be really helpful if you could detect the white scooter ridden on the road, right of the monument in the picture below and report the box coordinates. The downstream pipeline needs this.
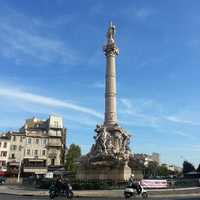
[124,183,148,199]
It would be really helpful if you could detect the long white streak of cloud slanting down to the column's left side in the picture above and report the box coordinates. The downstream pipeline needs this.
[0,87,103,118]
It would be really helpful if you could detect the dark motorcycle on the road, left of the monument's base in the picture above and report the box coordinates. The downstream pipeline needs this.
[49,183,74,199]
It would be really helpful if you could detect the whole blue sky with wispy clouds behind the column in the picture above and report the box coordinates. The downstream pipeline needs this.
[0,0,200,168]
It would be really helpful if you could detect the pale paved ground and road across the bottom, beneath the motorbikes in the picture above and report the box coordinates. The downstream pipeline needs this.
[0,185,200,200]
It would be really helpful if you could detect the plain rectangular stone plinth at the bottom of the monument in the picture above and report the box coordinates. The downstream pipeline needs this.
[76,161,131,182]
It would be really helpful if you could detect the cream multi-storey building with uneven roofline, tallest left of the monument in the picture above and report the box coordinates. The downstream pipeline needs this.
[2,116,66,175]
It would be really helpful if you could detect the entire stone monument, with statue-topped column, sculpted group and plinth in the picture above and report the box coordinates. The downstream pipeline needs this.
[77,23,131,181]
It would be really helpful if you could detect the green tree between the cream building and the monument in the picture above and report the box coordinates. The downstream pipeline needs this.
[65,144,81,173]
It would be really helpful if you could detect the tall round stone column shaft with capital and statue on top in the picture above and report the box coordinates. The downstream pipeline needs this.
[103,23,119,127]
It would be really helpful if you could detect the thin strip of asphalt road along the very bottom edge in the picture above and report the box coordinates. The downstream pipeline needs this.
[0,194,200,200]
